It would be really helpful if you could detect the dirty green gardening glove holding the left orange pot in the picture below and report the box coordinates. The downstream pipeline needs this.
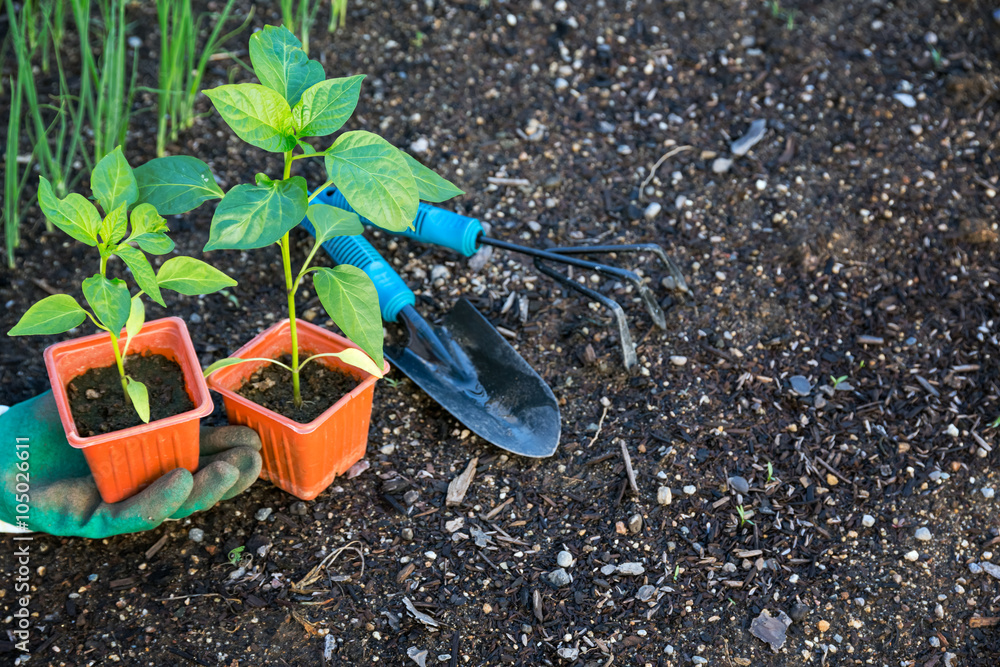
[0,392,261,539]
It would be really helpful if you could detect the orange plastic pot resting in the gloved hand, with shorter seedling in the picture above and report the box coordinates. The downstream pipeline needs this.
[45,317,212,503]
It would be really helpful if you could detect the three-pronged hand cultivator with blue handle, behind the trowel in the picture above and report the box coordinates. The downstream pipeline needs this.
[317,188,691,371]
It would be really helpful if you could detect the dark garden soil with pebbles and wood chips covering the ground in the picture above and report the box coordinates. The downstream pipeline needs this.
[0,0,1000,667]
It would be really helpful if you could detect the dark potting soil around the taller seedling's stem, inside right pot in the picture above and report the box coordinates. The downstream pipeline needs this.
[236,351,358,424]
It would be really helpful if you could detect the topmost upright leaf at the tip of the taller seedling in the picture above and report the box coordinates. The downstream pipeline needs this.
[250,25,326,106]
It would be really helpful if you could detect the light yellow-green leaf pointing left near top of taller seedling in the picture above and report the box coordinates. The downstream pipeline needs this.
[205,83,295,153]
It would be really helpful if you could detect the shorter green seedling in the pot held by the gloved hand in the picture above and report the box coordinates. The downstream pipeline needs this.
[7,147,236,422]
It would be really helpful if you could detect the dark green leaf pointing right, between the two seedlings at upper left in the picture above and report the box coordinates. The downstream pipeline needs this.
[135,155,222,215]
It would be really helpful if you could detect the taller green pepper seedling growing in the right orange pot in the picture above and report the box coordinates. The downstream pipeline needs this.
[205,26,462,406]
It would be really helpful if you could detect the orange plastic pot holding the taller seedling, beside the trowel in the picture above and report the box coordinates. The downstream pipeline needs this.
[208,320,389,500]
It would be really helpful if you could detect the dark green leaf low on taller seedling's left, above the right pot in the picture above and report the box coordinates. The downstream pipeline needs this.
[205,176,309,251]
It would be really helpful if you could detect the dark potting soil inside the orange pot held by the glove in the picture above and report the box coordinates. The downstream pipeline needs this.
[66,354,194,437]
